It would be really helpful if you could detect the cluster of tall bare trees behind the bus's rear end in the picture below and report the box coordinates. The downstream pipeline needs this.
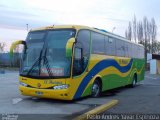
[125,15,160,65]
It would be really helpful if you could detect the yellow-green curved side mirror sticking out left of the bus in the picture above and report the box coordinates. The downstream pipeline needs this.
[10,40,27,58]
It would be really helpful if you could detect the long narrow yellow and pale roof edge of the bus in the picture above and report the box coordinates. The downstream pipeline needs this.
[30,25,144,47]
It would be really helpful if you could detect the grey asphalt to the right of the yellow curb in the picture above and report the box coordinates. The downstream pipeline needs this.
[104,72,160,114]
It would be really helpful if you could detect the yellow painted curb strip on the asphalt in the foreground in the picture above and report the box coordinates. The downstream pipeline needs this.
[73,100,118,120]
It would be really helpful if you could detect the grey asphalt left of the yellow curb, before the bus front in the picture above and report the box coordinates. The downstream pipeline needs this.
[0,71,114,120]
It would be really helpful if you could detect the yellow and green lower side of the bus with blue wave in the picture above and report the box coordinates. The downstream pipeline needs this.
[72,55,144,99]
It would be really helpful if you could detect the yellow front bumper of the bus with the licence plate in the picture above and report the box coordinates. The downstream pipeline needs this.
[19,86,72,100]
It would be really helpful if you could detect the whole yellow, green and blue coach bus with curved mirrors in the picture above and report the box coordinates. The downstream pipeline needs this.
[10,25,145,100]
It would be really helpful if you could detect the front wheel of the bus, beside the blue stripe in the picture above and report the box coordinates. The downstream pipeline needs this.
[91,80,101,97]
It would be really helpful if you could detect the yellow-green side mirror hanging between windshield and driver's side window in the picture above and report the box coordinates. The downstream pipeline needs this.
[66,38,75,57]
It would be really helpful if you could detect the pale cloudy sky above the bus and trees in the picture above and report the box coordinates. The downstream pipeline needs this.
[0,0,160,51]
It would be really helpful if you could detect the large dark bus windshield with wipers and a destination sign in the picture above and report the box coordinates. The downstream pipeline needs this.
[20,29,75,77]
